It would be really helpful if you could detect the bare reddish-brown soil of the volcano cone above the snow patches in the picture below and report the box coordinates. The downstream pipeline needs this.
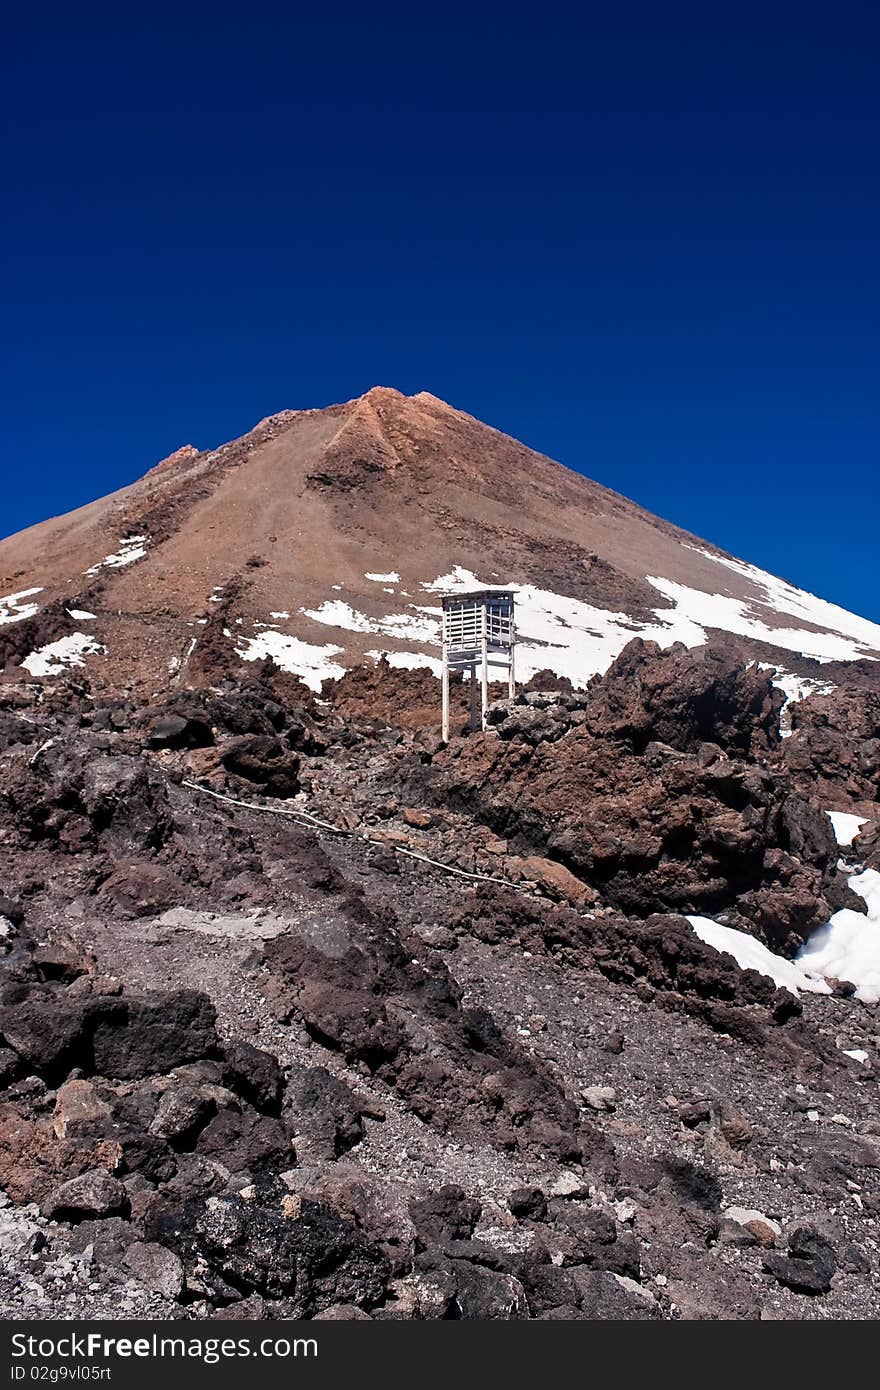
[0,388,873,689]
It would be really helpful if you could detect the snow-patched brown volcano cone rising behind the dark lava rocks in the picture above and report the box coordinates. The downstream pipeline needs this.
[0,386,880,695]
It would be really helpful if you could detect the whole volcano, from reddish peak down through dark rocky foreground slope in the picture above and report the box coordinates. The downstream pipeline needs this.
[0,388,880,1322]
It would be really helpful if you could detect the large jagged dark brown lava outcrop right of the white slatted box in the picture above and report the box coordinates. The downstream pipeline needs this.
[425,642,838,954]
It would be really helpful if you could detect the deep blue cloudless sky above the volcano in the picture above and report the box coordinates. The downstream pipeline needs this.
[0,0,880,620]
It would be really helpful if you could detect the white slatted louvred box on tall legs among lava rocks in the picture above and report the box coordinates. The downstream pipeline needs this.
[442,589,516,742]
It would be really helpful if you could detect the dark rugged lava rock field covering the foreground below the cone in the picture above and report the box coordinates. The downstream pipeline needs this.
[0,639,880,1321]
